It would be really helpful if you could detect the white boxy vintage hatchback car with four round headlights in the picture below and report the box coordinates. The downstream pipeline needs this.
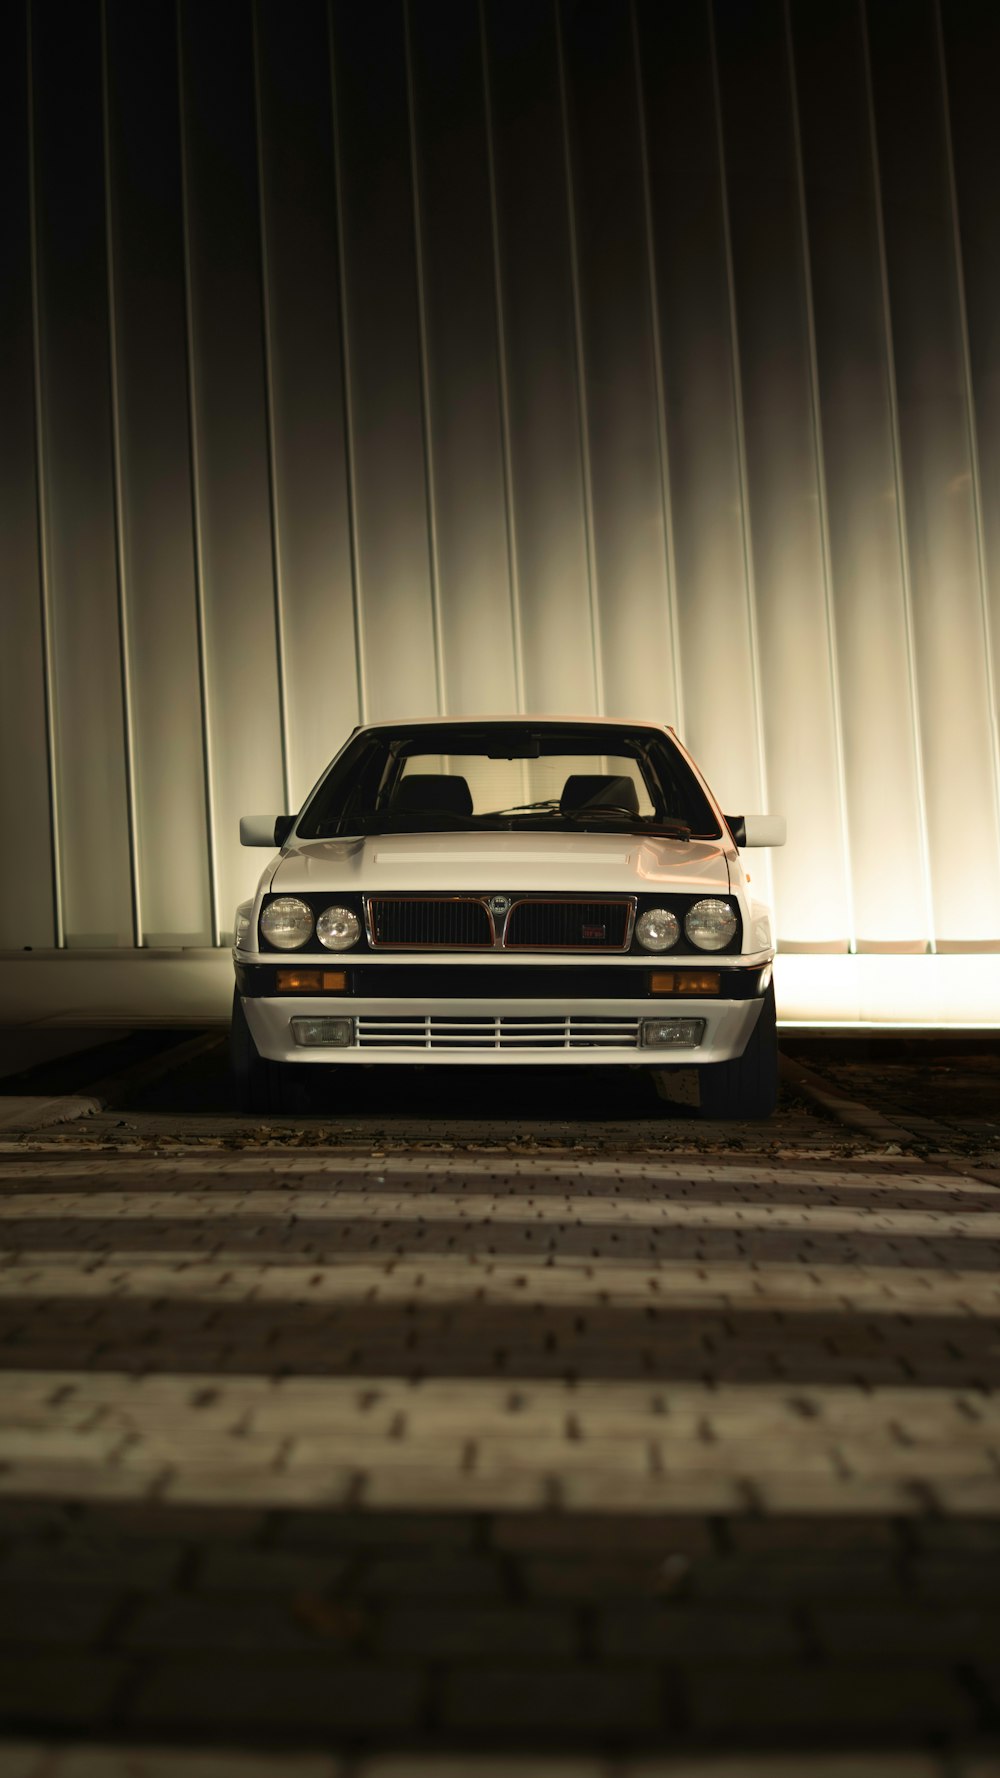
[231,717,785,1118]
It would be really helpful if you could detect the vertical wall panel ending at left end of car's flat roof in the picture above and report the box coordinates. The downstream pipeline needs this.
[333,0,438,717]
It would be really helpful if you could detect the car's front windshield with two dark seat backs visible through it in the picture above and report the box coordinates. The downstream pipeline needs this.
[297,722,721,839]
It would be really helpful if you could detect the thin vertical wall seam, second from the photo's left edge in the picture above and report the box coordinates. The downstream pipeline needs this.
[101,0,142,949]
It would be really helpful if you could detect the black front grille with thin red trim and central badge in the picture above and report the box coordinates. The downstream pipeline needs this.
[368,894,633,951]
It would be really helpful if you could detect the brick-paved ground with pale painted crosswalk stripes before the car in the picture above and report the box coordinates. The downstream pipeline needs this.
[0,1052,1000,1778]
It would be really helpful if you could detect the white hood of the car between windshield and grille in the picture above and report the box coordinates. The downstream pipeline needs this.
[270,832,730,894]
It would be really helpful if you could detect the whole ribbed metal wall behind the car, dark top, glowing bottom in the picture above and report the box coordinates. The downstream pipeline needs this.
[0,0,1000,949]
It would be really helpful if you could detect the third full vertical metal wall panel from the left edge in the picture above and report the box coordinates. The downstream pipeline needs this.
[107,0,212,944]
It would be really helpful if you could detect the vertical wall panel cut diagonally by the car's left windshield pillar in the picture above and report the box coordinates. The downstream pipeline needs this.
[256,0,359,809]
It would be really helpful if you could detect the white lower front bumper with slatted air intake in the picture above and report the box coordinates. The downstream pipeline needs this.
[237,957,770,1069]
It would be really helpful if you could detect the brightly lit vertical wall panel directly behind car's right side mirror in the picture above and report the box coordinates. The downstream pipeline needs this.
[717,0,851,948]
